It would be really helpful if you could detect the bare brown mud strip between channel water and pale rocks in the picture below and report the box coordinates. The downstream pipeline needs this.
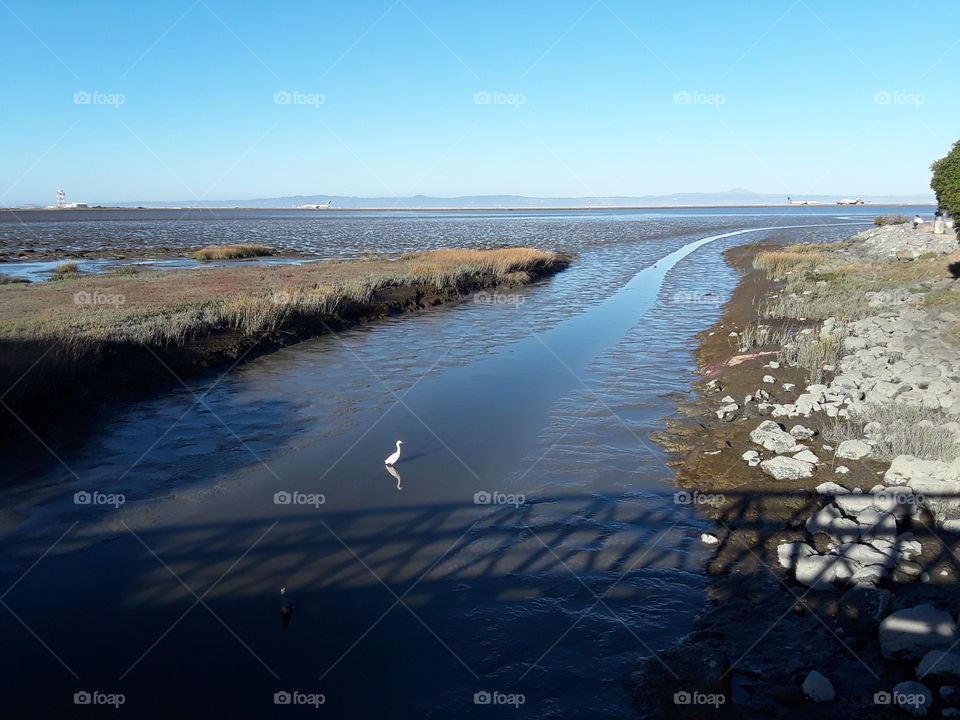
[626,245,958,719]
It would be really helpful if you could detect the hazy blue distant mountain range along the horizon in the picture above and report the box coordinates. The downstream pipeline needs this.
[9,188,934,209]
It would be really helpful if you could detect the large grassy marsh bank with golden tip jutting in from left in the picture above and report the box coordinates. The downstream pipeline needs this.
[0,248,565,345]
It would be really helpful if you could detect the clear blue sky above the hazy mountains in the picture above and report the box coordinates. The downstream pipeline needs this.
[0,0,960,205]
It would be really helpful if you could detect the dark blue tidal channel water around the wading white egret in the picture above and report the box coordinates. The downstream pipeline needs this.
[0,210,884,718]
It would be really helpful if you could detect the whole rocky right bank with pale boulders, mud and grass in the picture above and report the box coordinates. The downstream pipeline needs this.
[627,226,960,718]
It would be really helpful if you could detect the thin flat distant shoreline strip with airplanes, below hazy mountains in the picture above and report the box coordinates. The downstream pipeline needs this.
[0,202,937,214]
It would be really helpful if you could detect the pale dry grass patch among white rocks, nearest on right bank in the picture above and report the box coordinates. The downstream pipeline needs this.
[824,402,960,462]
